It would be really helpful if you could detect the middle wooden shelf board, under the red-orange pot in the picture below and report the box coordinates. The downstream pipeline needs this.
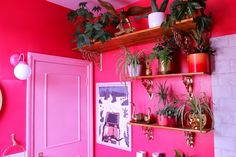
[127,72,208,80]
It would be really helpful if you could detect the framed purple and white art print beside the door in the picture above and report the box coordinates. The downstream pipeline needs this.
[96,82,131,151]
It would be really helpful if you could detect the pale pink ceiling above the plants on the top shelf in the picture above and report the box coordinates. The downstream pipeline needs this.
[47,0,137,10]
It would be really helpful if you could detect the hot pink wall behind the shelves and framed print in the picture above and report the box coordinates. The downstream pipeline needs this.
[95,0,236,157]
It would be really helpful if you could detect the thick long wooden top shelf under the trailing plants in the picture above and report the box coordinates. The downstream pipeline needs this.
[73,19,196,53]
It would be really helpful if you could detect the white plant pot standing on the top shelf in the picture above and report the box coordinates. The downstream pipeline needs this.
[148,12,165,28]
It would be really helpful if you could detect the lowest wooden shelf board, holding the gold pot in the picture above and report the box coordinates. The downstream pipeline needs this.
[128,122,212,133]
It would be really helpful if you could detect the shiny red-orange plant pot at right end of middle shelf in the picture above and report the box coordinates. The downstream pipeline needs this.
[187,53,210,73]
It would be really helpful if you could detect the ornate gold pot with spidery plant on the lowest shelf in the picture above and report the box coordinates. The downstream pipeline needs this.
[188,113,207,130]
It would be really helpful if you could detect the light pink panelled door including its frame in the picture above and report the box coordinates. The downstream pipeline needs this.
[27,53,93,157]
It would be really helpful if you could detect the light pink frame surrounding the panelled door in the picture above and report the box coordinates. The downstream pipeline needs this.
[26,52,94,157]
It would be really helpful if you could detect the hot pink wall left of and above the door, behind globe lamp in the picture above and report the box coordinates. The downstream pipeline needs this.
[0,0,80,156]
